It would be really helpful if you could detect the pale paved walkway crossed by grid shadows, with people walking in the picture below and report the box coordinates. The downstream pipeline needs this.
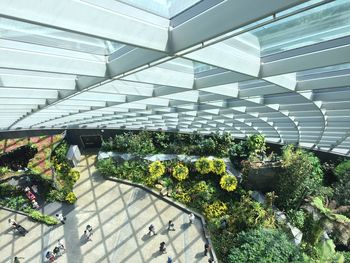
[0,156,208,263]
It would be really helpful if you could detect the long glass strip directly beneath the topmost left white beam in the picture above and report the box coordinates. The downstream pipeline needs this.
[0,17,124,55]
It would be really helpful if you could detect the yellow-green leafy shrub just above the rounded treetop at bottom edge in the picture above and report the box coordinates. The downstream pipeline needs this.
[228,195,275,233]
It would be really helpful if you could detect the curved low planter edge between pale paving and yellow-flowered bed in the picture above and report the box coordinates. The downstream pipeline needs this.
[104,176,218,262]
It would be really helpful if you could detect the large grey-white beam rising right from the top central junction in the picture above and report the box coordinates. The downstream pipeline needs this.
[171,0,305,53]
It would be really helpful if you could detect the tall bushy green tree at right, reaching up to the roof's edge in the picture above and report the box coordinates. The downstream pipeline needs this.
[276,145,323,210]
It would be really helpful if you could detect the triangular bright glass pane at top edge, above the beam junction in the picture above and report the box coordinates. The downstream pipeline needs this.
[118,0,201,18]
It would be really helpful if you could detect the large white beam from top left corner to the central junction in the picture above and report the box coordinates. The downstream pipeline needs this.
[0,0,168,51]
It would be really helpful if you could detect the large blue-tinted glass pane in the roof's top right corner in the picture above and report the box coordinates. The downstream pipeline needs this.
[246,0,350,56]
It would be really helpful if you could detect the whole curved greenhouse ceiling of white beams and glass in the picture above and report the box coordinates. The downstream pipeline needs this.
[0,0,350,156]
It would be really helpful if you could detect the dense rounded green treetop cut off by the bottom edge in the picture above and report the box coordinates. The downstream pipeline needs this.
[228,229,302,263]
